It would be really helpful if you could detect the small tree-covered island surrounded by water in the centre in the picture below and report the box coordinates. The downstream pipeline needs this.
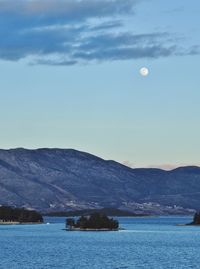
[66,213,119,231]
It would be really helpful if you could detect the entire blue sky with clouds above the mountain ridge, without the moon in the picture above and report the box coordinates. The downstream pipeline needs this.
[0,0,200,169]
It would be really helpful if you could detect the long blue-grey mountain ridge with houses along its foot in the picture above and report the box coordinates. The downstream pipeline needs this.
[0,148,200,214]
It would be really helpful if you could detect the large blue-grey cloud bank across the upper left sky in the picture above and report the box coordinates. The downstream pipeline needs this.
[0,0,195,65]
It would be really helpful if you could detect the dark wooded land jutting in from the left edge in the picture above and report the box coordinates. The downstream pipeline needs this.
[0,206,43,225]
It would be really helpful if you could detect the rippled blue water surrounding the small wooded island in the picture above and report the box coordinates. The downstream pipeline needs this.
[0,217,200,269]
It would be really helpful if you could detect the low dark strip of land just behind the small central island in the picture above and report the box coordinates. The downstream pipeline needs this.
[45,208,144,217]
